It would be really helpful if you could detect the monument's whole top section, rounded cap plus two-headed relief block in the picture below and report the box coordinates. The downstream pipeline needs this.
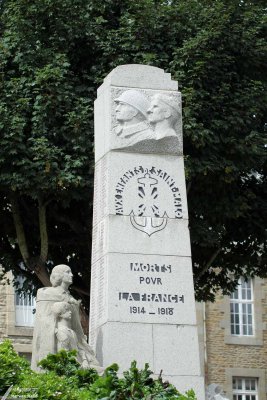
[95,65,182,161]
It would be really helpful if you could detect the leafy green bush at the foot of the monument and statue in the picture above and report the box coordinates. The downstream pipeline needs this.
[0,341,196,400]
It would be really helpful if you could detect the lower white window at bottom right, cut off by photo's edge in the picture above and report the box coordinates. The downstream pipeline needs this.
[233,377,258,400]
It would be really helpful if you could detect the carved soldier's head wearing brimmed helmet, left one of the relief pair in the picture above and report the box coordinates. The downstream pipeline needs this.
[114,89,152,138]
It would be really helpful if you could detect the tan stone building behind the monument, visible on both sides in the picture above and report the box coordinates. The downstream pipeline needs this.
[0,278,267,400]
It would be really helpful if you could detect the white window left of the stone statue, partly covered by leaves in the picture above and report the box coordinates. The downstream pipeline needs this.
[15,276,36,327]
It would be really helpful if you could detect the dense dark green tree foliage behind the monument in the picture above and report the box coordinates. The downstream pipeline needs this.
[0,0,267,300]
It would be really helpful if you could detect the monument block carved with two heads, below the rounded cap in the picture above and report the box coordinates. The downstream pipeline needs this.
[95,87,183,161]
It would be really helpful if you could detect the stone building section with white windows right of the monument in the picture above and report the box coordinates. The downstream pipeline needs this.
[202,278,267,400]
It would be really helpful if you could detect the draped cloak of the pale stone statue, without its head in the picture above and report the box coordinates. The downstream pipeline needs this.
[31,286,99,371]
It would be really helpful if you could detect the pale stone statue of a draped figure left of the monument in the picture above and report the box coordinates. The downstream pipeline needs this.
[31,264,102,372]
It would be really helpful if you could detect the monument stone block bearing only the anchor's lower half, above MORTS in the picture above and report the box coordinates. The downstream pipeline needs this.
[92,215,191,263]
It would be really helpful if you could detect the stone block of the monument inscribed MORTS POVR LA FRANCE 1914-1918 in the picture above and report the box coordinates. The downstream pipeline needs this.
[90,253,196,328]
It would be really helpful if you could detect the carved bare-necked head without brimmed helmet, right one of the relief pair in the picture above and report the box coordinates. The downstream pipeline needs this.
[147,94,181,139]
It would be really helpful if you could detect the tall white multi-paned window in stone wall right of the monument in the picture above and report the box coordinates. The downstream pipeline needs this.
[230,278,254,336]
